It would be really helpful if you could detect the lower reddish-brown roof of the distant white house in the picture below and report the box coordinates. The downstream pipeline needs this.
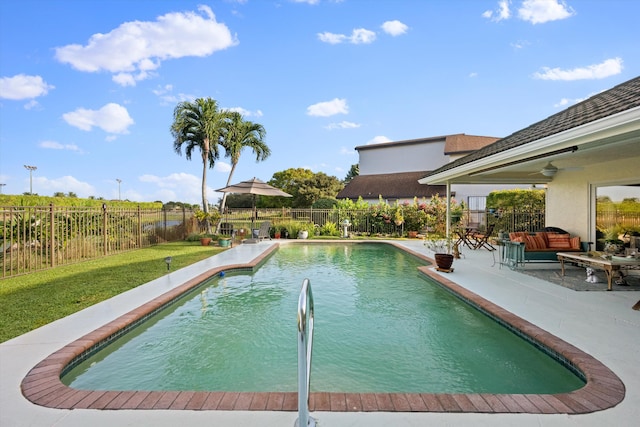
[336,171,446,200]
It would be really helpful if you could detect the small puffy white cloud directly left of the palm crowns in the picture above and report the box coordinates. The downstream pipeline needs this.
[62,103,134,134]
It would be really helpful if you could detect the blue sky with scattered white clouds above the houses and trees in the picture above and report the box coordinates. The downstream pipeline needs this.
[0,0,640,203]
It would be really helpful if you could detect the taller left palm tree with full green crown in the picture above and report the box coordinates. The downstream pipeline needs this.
[171,98,225,231]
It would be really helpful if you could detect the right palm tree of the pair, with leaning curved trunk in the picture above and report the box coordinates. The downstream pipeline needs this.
[220,111,271,226]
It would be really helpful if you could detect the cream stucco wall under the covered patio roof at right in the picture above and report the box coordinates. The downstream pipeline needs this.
[546,157,640,242]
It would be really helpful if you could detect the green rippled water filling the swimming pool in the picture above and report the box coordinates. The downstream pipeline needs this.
[62,243,584,394]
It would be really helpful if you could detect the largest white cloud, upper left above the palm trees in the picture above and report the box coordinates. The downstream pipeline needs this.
[55,6,238,86]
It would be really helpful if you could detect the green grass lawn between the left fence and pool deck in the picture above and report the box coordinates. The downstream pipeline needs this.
[0,242,224,342]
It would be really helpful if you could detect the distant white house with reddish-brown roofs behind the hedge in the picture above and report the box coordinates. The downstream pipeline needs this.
[337,133,517,211]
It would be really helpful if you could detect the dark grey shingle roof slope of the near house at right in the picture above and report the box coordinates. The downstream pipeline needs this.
[423,77,640,177]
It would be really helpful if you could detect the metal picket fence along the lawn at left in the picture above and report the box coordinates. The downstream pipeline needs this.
[0,205,194,278]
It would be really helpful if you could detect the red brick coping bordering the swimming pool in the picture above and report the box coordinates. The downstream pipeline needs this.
[21,241,625,414]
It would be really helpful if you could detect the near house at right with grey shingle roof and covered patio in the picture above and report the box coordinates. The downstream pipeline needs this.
[419,77,640,242]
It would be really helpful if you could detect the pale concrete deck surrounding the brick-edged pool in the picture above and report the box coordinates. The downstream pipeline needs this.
[0,240,640,426]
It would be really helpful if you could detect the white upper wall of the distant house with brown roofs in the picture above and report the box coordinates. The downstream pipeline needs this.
[358,139,449,175]
